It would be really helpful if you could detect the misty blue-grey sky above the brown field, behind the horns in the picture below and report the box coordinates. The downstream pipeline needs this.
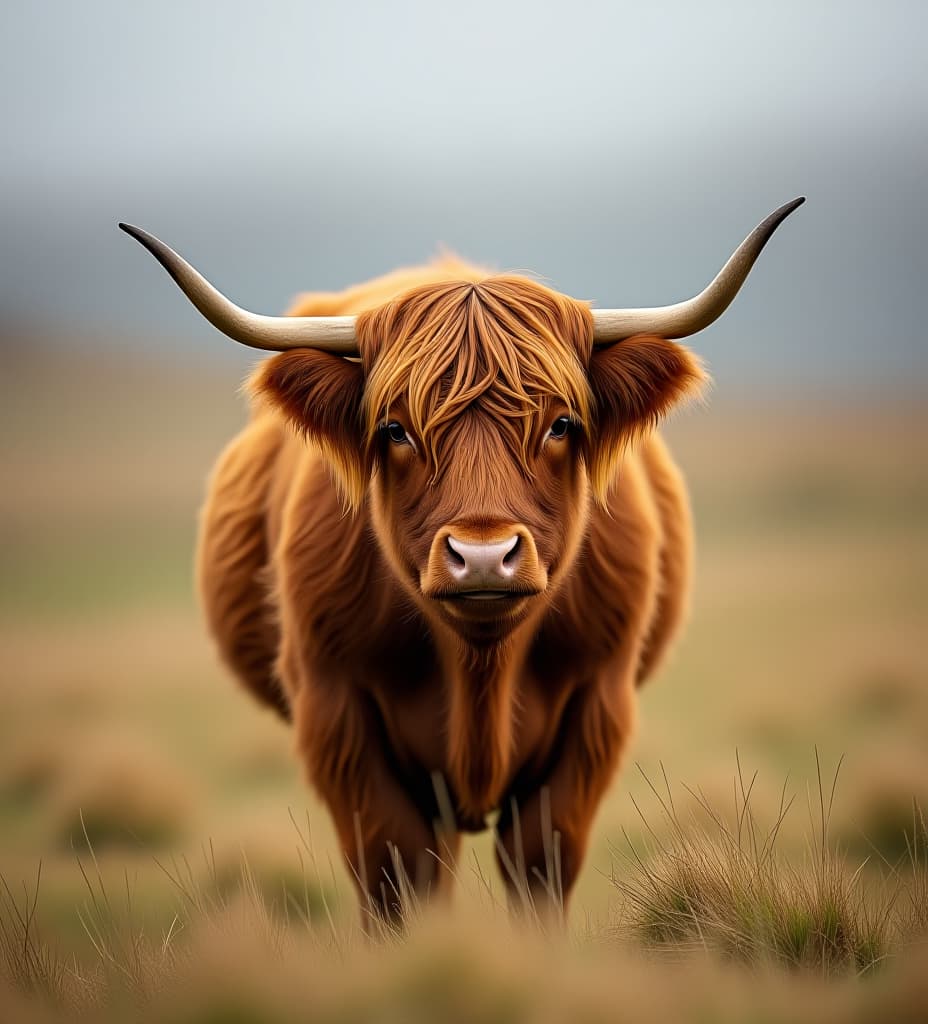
[0,0,928,387]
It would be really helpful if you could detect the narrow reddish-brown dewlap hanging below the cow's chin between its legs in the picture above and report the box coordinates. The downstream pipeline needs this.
[441,630,529,820]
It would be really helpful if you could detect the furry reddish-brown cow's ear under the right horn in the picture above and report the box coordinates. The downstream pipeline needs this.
[588,335,707,502]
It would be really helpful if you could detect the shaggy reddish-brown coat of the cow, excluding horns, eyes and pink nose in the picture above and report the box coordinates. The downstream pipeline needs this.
[199,259,703,913]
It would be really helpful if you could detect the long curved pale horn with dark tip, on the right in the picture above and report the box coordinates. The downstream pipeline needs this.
[593,197,805,345]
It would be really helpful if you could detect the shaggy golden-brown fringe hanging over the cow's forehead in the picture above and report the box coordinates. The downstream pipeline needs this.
[350,278,592,479]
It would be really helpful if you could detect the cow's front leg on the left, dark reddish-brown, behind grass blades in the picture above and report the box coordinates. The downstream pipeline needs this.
[294,687,458,930]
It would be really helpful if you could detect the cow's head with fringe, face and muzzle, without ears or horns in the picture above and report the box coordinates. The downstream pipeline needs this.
[358,278,592,641]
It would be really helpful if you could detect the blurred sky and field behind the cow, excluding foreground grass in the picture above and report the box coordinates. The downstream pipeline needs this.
[0,0,928,942]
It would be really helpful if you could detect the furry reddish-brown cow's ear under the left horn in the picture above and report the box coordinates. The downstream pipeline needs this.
[249,348,371,509]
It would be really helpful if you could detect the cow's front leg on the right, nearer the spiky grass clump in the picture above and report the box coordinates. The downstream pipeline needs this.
[497,679,635,918]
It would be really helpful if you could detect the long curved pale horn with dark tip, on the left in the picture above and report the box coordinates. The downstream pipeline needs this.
[119,224,357,355]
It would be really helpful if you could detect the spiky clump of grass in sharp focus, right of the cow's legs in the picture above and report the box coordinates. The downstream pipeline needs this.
[613,752,892,974]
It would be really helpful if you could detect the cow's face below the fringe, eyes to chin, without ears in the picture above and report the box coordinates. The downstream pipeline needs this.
[371,391,589,641]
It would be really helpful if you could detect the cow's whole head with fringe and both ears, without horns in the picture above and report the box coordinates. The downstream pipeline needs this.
[256,278,700,643]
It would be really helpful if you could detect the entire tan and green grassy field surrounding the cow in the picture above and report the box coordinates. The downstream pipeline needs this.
[0,339,928,1021]
